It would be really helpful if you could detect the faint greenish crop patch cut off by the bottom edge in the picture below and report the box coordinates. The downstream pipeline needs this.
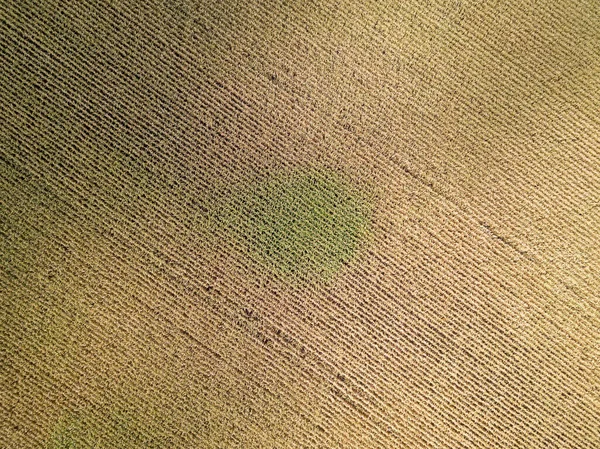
[47,410,170,449]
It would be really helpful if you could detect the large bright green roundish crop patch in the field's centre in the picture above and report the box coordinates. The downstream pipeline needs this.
[215,170,370,279]
